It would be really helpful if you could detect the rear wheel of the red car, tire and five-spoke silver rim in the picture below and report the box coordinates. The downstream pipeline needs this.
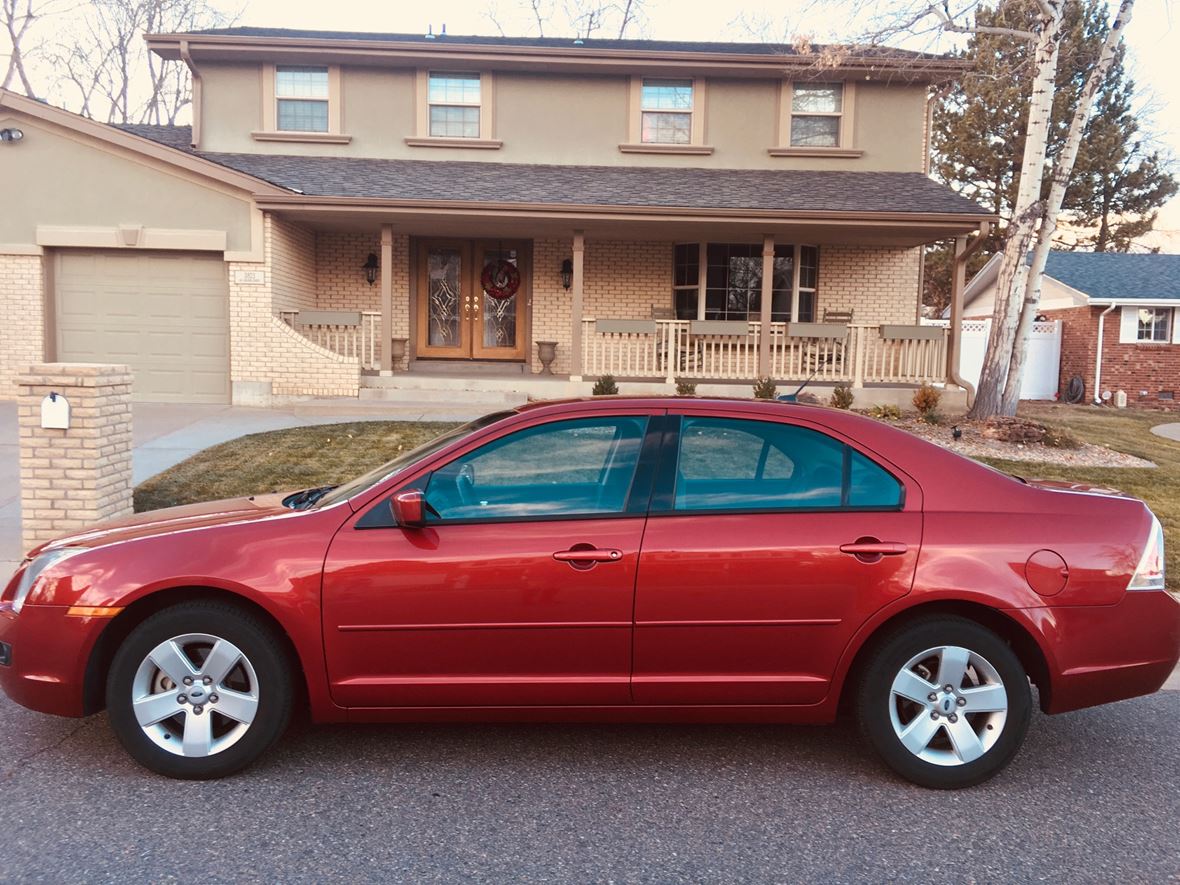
[857,617,1033,789]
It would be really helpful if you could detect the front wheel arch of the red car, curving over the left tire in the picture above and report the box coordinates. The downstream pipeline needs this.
[83,586,310,716]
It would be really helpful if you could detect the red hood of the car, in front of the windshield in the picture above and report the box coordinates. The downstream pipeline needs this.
[30,492,300,556]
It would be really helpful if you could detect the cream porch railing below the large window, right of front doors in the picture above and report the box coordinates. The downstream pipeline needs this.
[582,320,946,386]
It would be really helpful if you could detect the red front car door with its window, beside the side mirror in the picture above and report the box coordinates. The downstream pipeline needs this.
[323,412,660,707]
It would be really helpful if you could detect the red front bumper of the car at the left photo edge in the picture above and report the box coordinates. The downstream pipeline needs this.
[0,603,103,716]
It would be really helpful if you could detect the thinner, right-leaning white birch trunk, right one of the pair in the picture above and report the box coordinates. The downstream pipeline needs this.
[1001,0,1135,415]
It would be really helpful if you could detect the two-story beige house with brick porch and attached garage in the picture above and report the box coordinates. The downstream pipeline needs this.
[0,28,990,404]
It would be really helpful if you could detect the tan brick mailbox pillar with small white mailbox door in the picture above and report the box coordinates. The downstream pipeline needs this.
[17,362,132,550]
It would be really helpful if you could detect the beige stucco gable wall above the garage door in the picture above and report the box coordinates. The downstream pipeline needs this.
[0,111,251,251]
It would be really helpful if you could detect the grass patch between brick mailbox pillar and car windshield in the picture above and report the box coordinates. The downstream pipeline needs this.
[136,421,454,511]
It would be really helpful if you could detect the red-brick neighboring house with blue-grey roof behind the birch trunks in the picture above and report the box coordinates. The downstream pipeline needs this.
[964,251,1180,408]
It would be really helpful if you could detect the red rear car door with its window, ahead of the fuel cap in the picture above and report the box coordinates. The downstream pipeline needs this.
[632,411,922,704]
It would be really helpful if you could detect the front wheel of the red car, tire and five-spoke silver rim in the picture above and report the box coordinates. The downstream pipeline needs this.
[106,602,291,780]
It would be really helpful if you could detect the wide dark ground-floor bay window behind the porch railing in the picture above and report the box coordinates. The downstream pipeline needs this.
[673,243,819,322]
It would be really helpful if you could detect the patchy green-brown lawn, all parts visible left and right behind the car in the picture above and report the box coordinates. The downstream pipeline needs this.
[136,404,1180,581]
